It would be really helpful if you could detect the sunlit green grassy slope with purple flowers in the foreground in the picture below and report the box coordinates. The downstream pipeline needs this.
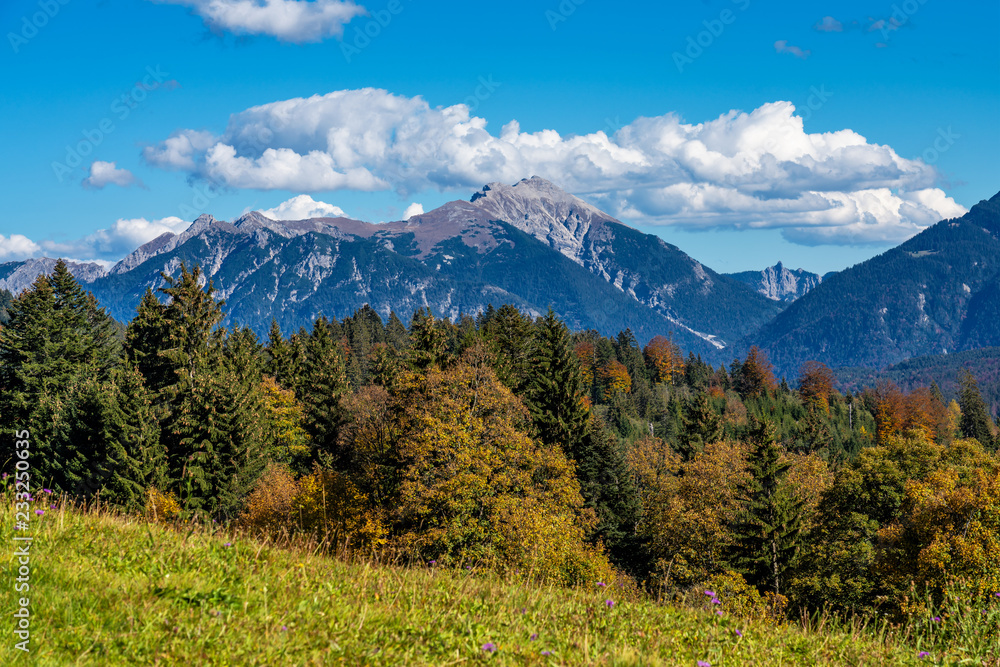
[0,506,964,666]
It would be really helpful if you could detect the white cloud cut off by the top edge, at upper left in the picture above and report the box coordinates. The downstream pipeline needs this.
[153,0,368,44]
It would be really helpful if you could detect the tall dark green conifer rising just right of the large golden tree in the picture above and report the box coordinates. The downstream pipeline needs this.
[523,309,589,456]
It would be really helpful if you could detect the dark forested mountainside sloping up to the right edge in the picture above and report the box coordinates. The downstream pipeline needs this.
[742,194,1000,376]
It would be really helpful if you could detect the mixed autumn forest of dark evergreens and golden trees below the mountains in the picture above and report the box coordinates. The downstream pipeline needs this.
[0,262,1000,618]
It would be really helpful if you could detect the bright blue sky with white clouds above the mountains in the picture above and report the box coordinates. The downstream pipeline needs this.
[0,0,1000,272]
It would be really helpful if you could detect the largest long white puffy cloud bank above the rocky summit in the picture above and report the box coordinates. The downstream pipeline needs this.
[146,89,964,244]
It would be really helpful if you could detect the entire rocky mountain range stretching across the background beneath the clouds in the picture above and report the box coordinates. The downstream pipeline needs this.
[0,177,1000,377]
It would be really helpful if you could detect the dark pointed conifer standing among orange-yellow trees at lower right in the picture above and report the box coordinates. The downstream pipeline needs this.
[732,418,802,594]
